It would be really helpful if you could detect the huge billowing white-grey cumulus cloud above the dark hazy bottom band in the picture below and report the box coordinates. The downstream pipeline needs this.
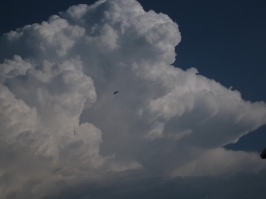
[0,0,266,199]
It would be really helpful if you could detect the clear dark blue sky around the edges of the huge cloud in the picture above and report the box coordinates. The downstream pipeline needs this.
[0,0,266,152]
